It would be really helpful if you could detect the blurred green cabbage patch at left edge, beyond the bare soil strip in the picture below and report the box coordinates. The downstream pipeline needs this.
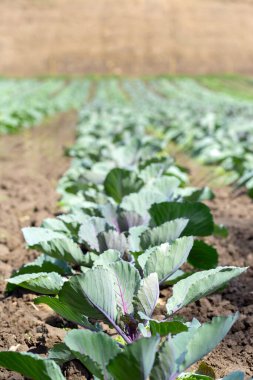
[0,79,89,134]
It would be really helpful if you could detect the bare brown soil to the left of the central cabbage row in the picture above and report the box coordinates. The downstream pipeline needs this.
[0,113,76,380]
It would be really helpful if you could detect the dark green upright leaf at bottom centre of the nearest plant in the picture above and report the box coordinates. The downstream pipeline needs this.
[107,337,160,380]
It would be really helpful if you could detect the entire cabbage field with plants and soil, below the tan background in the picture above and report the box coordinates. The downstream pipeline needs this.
[0,76,253,380]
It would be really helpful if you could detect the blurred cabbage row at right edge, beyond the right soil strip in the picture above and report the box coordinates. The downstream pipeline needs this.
[150,79,253,198]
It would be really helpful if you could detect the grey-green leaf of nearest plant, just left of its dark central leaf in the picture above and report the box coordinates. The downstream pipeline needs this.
[64,330,121,379]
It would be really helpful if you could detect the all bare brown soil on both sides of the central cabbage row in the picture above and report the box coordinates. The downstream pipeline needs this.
[0,118,253,380]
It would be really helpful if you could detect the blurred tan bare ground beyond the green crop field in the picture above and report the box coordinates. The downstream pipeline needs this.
[0,0,253,76]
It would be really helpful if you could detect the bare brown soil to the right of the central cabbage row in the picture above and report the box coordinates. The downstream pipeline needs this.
[200,189,253,376]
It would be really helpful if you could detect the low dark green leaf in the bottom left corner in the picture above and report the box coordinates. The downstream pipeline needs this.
[0,351,65,380]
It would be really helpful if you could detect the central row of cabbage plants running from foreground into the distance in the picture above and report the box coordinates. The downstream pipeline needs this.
[0,81,246,380]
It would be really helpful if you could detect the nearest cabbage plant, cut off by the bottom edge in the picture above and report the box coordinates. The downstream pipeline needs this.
[0,315,244,380]
